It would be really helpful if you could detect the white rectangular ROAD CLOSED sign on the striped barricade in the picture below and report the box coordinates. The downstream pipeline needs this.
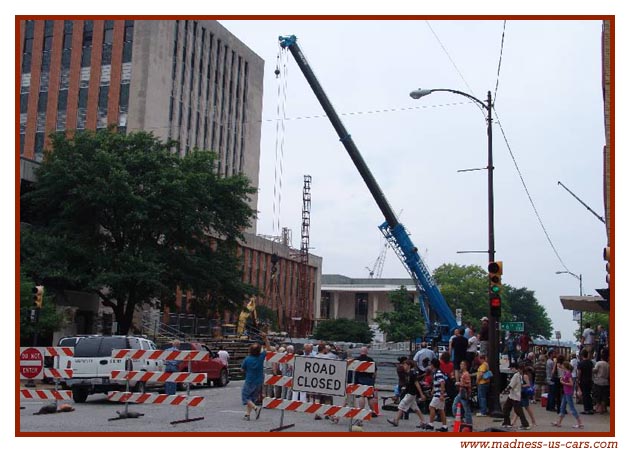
[293,356,348,396]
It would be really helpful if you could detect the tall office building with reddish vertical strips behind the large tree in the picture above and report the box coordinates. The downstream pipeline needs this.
[19,20,321,340]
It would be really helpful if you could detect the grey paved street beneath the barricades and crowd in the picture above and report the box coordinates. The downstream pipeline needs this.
[20,381,610,435]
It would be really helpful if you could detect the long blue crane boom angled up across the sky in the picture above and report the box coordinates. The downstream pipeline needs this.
[278,35,457,342]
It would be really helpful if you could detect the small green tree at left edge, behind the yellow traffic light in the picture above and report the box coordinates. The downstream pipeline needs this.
[20,272,63,345]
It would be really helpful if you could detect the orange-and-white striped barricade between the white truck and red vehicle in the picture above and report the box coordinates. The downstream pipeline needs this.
[107,349,210,424]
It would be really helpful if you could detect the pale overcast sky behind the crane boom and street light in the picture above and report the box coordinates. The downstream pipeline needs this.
[220,20,606,339]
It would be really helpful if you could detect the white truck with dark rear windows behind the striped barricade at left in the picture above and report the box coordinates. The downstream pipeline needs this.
[64,336,164,403]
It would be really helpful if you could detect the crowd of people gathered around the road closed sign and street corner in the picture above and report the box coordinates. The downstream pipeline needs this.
[242,317,610,431]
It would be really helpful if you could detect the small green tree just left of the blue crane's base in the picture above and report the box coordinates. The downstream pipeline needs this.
[375,286,425,342]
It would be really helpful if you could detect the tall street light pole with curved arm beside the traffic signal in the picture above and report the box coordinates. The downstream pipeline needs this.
[409,88,502,416]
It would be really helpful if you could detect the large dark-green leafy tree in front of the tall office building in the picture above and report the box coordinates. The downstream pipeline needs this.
[20,129,255,333]
